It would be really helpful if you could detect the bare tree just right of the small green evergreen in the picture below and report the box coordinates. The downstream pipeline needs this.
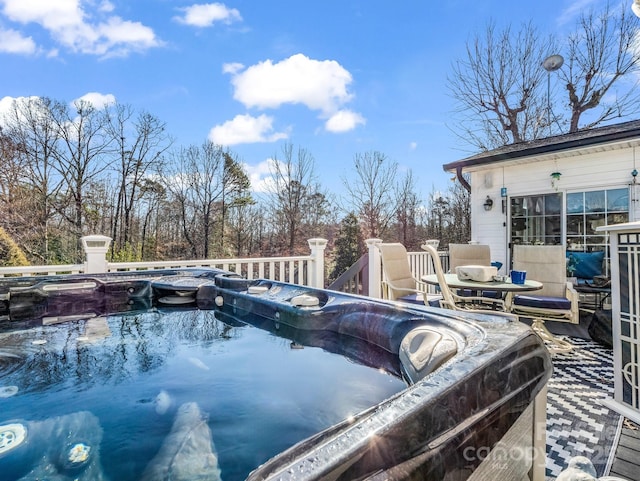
[342,151,398,238]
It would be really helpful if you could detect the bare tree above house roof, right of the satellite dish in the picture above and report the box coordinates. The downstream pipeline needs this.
[558,2,640,132]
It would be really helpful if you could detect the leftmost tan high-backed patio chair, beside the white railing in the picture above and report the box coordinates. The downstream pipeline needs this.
[378,242,426,304]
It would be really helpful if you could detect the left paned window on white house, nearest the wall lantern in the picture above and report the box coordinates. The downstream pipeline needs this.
[511,193,562,245]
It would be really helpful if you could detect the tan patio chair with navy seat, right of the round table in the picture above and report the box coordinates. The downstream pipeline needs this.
[507,245,580,352]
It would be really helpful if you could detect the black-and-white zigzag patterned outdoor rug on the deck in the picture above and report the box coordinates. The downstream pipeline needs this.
[546,337,622,479]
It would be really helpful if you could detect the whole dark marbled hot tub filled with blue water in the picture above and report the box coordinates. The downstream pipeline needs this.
[0,269,552,481]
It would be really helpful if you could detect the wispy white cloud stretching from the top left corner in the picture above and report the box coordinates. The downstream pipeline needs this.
[2,0,163,57]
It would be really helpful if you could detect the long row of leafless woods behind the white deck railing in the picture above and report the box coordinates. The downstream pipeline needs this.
[0,97,470,282]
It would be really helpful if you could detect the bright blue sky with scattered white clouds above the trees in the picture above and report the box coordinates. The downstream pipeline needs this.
[0,0,620,198]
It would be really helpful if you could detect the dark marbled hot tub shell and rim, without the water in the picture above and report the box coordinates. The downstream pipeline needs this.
[0,269,552,480]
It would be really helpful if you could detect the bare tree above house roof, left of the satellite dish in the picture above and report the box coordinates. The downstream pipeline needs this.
[448,23,554,150]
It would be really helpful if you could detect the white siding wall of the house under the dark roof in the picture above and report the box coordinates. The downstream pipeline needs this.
[468,144,640,273]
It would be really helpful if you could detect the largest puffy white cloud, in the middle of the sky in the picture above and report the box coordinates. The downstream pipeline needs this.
[225,54,352,114]
